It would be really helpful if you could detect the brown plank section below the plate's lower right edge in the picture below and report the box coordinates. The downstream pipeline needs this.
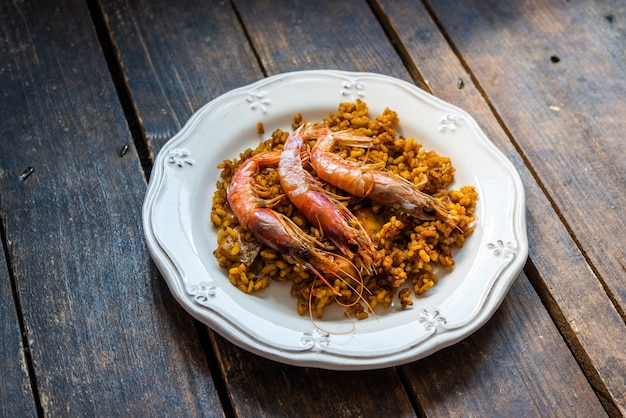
[400,275,606,417]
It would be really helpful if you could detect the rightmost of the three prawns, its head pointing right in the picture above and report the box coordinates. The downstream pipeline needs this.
[310,128,451,220]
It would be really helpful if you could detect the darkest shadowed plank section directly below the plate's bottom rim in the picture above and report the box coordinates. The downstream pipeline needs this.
[215,337,416,417]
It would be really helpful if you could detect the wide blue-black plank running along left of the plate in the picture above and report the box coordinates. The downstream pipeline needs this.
[0,0,222,416]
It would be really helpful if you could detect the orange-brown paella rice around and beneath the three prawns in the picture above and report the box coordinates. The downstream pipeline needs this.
[211,100,478,319]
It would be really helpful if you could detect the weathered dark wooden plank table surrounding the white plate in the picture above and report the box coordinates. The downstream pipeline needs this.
[0,0,626,417]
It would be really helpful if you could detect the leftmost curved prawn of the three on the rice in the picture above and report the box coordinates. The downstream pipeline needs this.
[227,151,364,298]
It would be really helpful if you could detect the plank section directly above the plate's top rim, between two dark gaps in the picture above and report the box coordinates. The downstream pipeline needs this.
[234,0,410,81]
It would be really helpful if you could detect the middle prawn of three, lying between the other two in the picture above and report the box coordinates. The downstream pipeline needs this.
[278,124,375,274]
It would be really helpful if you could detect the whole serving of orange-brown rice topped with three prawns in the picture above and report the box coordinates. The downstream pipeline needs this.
[211,100,478,320]
